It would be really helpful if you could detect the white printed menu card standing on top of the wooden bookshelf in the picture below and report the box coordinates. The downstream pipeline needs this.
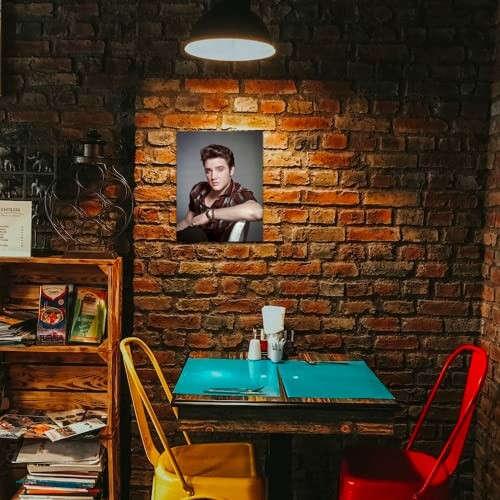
[0,200,31,257]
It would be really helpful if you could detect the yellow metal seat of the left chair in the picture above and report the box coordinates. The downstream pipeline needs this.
[151,443,265,500]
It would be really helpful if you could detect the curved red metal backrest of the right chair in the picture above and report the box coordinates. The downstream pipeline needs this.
[406,345,488,497]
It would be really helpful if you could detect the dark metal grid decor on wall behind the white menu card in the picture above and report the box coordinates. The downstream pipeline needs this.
[0,142,58,254]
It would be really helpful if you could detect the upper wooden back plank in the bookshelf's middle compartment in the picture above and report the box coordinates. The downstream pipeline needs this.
[8,364,109,390]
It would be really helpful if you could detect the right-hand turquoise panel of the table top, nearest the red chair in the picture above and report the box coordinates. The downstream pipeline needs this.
[278,361,394,399]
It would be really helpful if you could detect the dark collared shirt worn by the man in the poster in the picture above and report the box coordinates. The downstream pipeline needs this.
[189,181,257,241]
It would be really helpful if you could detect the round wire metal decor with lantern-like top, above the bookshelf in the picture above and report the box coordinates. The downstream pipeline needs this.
[45,130,133,253]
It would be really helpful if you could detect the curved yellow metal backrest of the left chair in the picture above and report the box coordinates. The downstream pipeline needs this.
[120,337,194,495]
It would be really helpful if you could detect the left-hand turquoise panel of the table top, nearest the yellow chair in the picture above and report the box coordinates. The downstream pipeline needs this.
[174,358,280,397]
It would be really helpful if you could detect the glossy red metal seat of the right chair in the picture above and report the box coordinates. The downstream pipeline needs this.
[340,447,449,500]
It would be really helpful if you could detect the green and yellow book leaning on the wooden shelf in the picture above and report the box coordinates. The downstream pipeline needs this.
[69,286,107,344]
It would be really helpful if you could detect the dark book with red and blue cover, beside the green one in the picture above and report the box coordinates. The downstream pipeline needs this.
[36,284,69,345]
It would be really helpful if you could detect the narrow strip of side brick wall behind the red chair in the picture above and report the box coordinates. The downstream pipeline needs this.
[474,4,500,500]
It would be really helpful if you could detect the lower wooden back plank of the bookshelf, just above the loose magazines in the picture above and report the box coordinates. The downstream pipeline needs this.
[9,391,106,411]
